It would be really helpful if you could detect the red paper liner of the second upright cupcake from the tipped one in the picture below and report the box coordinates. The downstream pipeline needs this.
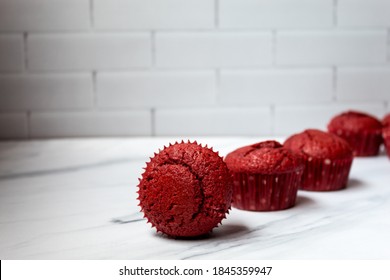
[300,157,353,191]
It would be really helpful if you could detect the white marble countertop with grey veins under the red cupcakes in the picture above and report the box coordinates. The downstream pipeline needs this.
[0,137,390,259]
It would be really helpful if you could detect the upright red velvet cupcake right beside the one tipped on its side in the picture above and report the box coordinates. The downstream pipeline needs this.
[225,141,304,211]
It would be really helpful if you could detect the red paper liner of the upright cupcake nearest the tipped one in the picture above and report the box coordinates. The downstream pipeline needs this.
[232,169,303,211]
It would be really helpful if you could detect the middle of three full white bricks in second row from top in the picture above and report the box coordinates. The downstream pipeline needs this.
[156,32,273,68]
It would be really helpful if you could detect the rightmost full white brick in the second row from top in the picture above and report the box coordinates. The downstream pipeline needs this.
[276,30,388,65]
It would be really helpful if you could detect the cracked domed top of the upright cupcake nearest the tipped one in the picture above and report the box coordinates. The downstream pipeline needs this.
[225,141,304,174]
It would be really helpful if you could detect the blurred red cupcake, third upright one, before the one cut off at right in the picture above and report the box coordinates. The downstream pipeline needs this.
[328,111,382,156]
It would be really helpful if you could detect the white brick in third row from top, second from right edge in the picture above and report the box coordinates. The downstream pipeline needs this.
[219,69,333,105]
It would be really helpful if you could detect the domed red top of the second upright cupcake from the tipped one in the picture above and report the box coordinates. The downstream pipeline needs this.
[284,129,353,159]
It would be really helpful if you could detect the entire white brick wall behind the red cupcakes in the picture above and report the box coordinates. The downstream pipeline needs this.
[0,0,390,139]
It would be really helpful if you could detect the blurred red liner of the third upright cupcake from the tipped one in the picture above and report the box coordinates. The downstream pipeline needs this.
[329,129,383,157]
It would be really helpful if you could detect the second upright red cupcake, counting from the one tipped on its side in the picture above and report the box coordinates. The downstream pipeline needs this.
[284,129,353,191]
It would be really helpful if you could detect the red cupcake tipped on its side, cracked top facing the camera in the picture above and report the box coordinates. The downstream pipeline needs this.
[138,142,232,237]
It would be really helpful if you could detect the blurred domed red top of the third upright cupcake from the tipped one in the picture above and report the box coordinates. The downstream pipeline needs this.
[328,111,382,132]
